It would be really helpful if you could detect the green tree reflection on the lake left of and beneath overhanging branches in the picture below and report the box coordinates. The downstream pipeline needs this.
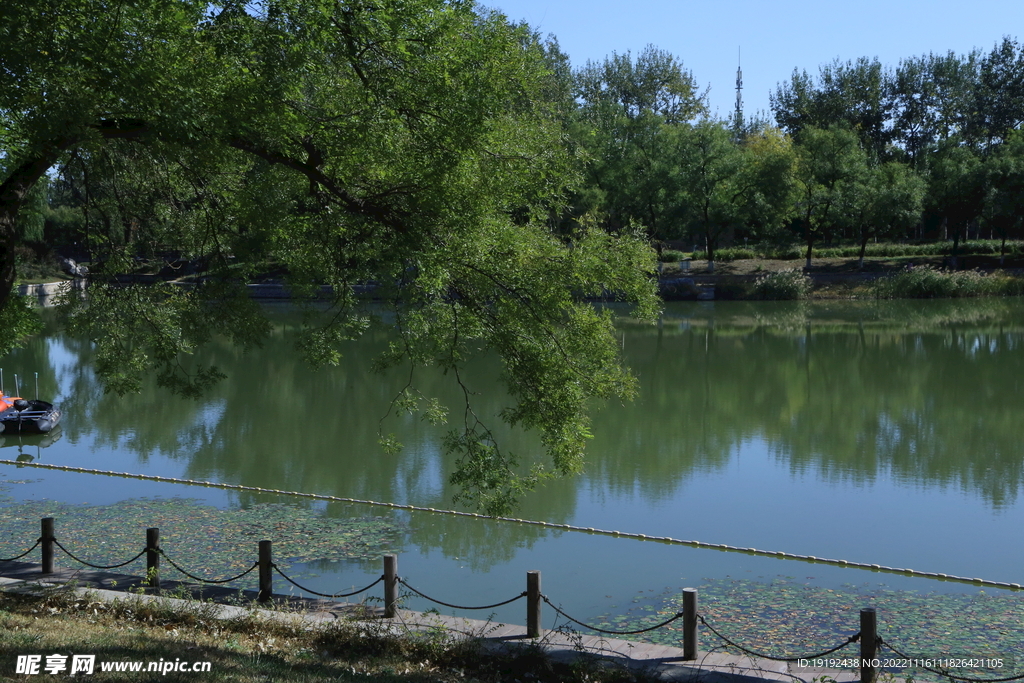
[51,317,575,566]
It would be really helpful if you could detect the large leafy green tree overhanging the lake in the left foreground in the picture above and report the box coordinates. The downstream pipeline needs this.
[0,0,654,512]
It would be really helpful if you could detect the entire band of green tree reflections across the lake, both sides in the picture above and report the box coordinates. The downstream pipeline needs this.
[36,300,1024,568]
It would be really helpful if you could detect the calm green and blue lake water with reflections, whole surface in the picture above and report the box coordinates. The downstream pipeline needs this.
[0,299,1024,667]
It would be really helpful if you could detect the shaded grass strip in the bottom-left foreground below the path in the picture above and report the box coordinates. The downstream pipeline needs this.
[0,590,655,683]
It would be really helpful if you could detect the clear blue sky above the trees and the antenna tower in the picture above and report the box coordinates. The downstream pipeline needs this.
[481,0,1024,122]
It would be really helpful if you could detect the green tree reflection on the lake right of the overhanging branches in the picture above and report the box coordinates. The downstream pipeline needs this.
[614,300,1024,507]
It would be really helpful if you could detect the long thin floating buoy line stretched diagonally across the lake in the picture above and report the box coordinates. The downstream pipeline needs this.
[0,460,1021,591]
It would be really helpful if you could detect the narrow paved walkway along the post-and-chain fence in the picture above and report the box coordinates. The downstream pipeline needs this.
[0,562,859,683]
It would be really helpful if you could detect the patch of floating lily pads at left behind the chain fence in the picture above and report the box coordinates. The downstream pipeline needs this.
[0,496,403,585]
